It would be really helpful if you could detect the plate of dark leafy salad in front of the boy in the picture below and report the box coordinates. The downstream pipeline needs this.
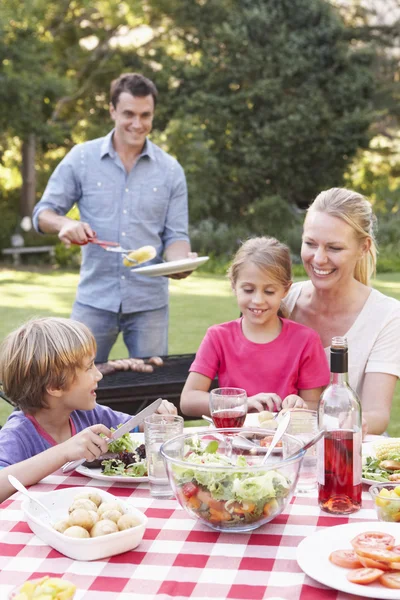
[76,433,148,483]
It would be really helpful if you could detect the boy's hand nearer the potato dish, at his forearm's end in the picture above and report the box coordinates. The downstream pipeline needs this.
[61,424,112,462]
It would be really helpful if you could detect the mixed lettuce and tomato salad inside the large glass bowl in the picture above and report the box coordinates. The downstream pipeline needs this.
[172,440,291,528]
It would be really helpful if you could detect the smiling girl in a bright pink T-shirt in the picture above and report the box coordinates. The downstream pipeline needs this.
[181,237,329,416]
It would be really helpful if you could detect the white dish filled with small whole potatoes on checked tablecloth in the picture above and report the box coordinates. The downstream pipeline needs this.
[22,486,147,560]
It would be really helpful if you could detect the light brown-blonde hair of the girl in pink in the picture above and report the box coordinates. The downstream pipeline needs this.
[228,236,292,289]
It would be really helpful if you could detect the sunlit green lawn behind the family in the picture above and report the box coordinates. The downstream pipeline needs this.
[0,269,400,437]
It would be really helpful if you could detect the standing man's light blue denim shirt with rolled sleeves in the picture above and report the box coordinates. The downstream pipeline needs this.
[33,130,189,313]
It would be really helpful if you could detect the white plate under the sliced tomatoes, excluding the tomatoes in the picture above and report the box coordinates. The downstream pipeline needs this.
[296,522,400,600]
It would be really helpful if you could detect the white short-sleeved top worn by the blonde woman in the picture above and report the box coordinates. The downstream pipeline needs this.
[284,281,400,395]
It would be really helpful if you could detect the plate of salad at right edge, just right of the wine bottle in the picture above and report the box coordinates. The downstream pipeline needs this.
[362,438,400,485]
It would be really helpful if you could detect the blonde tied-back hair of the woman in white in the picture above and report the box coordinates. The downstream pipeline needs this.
[306,188,378,285]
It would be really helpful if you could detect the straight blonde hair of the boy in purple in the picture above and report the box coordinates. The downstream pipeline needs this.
[0,317,96,414]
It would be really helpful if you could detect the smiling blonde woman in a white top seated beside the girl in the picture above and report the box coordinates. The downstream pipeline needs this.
[284,188,400,434]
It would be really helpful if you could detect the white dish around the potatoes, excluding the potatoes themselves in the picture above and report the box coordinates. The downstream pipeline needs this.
[22,486,147,560]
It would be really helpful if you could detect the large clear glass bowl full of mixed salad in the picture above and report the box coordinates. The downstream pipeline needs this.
[161,428,304,532]
